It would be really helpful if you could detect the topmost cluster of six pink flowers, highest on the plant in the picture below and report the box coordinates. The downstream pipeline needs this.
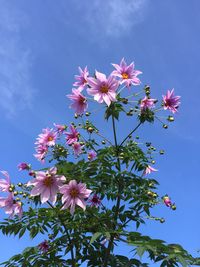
[67,58,180,121]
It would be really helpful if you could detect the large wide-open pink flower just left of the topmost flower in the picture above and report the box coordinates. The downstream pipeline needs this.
[87,71,119,106]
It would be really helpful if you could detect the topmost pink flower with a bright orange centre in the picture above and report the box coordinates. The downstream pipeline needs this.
[111,58,142,87]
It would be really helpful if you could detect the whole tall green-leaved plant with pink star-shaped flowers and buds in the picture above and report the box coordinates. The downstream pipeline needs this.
[0,59,200,267]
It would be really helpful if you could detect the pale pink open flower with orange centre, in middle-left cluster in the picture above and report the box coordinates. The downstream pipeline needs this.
[35,128,57,146]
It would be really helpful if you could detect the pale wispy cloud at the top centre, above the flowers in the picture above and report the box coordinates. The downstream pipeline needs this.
[75,0,148,37]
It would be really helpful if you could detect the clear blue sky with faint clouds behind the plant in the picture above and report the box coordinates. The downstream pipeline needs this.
[0,0,200,266]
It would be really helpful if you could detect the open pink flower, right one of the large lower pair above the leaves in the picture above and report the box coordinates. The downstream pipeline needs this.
[60,180,92,215]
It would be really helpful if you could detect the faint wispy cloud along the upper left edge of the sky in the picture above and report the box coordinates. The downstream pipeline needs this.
[0,1,34,116]
